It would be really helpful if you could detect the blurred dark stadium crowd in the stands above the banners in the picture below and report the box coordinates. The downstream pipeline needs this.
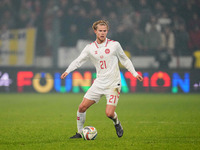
[0,0,200,56]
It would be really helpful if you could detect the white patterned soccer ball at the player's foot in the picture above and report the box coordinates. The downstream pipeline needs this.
[81,126,97,140]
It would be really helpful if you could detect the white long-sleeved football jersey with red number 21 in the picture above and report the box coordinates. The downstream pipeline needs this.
[66,38,138,88]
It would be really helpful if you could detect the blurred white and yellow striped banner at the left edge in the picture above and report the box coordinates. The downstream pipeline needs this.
[0,28,36,66]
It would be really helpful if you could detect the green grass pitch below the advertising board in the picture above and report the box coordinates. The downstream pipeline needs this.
[0,94,200,150]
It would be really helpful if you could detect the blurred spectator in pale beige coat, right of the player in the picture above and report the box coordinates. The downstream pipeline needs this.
[161,27,175,55]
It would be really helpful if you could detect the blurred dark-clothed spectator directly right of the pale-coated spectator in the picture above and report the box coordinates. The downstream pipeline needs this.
[175,24,190,56]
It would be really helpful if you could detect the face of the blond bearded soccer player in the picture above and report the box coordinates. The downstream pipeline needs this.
[94,25,108,44]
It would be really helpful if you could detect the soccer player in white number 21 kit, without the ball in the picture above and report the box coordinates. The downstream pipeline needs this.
[61,20,143,138]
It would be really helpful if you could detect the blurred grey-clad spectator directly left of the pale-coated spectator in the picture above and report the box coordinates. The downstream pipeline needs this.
[146,26,162,56]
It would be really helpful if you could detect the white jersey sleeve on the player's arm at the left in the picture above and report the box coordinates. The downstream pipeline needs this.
[65,46,89,74]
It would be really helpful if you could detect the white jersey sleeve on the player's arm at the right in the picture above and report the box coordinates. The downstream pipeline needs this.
[116,43,138,77]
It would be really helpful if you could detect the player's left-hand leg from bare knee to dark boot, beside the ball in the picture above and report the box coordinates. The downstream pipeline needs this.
[70,97,95,138]
